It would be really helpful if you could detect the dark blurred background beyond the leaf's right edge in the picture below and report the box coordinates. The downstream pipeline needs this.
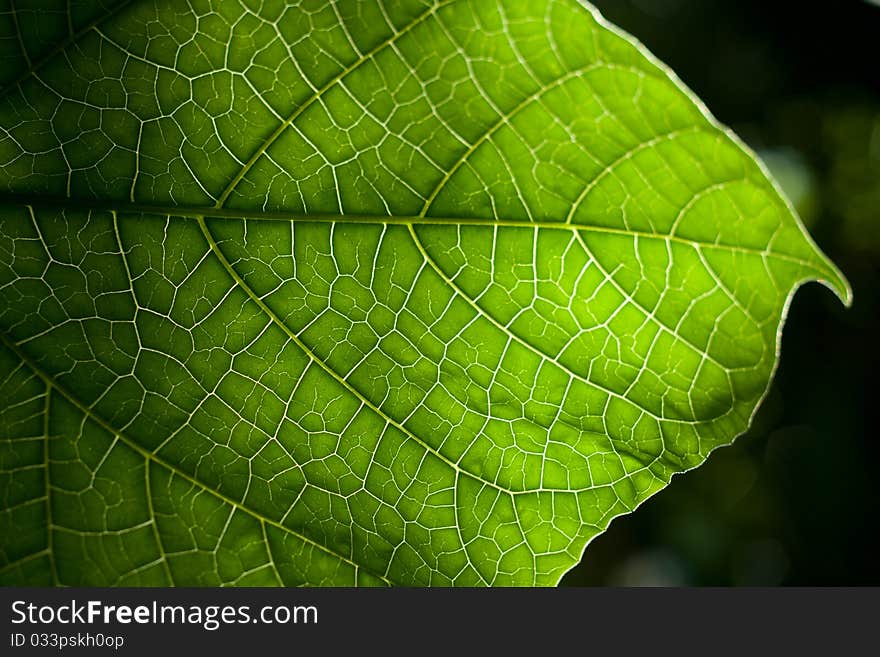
[562,0,880,586]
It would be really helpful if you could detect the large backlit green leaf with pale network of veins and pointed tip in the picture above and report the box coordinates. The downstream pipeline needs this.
[0,0,850,585]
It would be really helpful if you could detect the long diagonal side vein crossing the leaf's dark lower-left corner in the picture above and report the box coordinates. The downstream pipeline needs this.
[0,333,391,586]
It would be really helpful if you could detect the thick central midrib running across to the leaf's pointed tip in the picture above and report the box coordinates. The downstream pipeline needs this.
[0,194,828,268]
